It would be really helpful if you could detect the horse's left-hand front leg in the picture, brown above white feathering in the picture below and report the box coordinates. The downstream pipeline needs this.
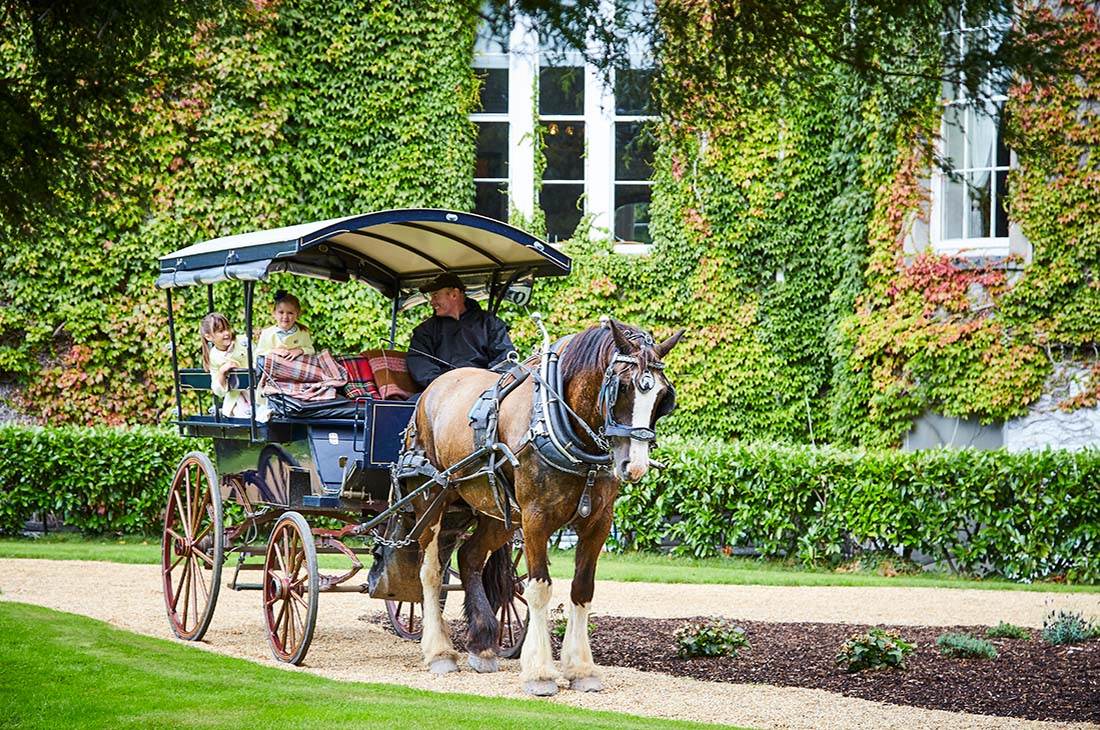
[519,518,560,697]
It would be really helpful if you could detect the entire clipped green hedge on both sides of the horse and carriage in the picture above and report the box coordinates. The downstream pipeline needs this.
[0,425,1100,583]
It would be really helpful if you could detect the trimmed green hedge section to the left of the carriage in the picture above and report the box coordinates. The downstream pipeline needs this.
[0,425,195,533]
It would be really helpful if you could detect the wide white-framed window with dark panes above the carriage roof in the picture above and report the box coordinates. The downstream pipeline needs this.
[471,3,656,248]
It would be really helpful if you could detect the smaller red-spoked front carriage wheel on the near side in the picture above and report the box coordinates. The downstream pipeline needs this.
[263,512,319,664]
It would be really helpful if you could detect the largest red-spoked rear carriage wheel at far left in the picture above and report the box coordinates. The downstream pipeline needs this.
[161,451,224,641]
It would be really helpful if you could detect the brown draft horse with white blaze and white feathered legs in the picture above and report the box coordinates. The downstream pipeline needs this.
[405,321,683,695]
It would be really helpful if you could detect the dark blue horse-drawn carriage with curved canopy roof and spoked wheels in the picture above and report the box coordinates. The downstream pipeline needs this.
[157,209,571,664]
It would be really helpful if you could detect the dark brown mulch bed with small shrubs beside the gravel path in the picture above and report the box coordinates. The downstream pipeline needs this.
[576,616,1100,722]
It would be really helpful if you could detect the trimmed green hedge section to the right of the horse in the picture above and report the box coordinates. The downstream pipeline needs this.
[616,442,1100,583]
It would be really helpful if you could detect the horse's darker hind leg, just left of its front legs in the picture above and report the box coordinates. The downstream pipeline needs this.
[459,517,512,672]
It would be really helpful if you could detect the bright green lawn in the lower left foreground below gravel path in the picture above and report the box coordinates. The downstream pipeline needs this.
[0,602,730,730]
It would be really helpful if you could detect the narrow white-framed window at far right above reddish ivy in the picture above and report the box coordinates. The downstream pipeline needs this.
[932,9,1011,256]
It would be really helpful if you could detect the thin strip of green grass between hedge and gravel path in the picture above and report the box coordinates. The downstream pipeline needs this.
[0,533,1100,593]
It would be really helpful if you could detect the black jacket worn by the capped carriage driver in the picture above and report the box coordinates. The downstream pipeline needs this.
[407,297,515,387]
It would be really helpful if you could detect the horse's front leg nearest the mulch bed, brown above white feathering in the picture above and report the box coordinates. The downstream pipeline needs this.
[561,509,612,692]
